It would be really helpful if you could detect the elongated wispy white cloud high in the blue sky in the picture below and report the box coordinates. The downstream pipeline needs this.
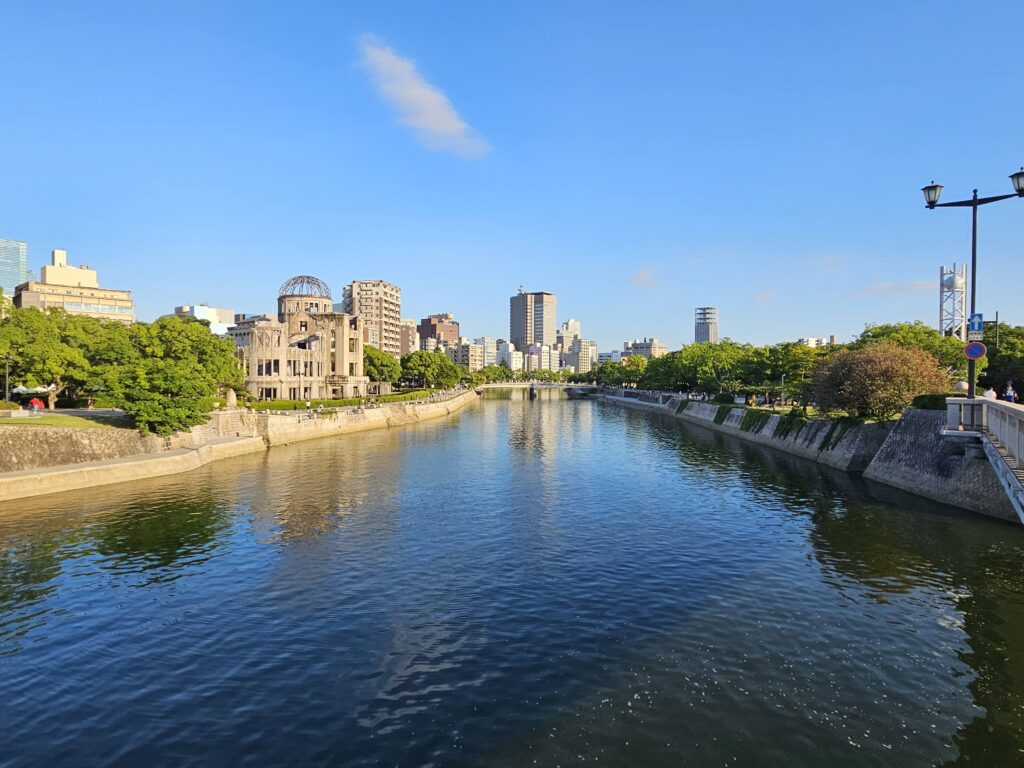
[359,35,490,158]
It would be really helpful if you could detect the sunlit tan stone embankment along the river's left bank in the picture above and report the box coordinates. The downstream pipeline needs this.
[0,390,476,501]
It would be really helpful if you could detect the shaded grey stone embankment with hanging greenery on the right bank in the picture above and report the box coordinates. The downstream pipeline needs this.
[602,390,1018,521]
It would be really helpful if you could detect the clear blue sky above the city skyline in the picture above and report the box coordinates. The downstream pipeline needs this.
[0,0,1024,349]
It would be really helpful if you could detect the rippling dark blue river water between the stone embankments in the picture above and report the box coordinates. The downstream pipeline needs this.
[0,390,1024,768]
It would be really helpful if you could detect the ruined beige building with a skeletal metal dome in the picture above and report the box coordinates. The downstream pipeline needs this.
[228,275,371,400]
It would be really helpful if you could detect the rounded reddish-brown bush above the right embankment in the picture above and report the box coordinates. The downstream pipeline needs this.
[813,342,949,419]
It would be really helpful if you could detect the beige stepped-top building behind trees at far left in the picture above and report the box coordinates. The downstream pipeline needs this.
[14,248,135,324]
